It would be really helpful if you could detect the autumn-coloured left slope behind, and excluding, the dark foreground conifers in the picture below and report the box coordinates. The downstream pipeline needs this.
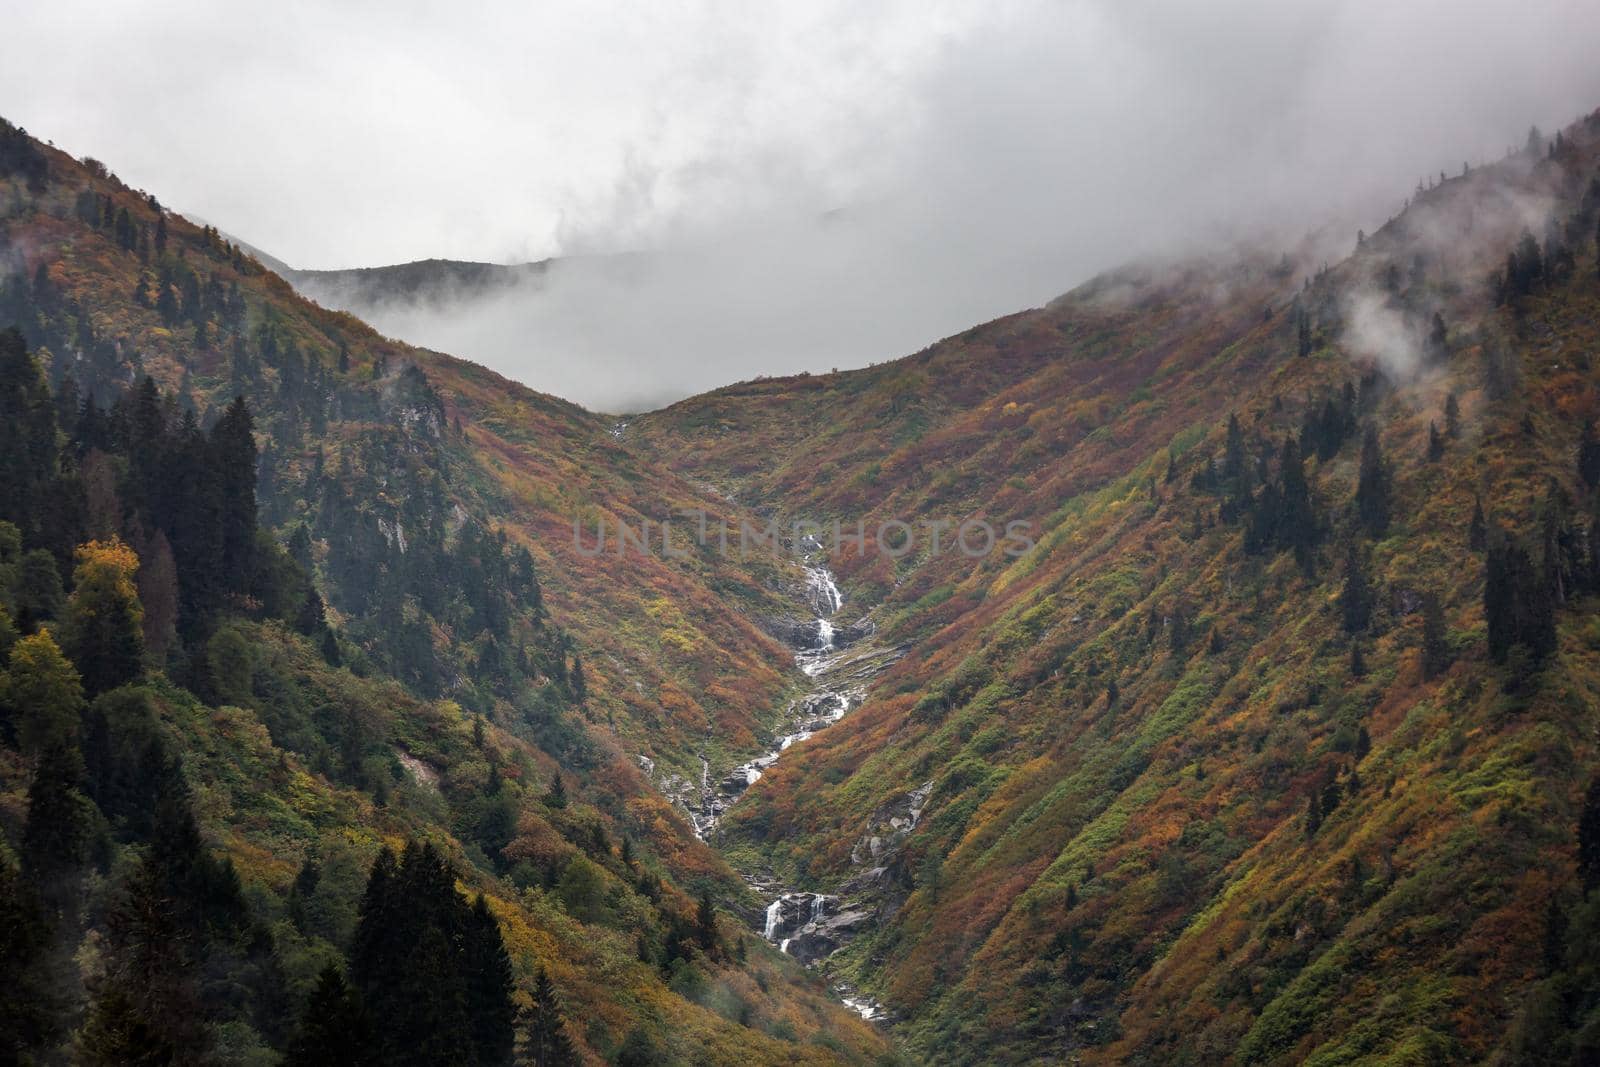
[0,125,885,1062]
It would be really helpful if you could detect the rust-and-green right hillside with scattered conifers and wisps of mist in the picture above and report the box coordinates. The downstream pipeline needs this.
[630,117,1600,1064]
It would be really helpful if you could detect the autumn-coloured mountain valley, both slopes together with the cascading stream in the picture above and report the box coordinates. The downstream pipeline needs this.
[0,106,1600,1064]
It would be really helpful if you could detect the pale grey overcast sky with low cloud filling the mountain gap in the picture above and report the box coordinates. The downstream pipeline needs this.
[9,0,1600,411]
